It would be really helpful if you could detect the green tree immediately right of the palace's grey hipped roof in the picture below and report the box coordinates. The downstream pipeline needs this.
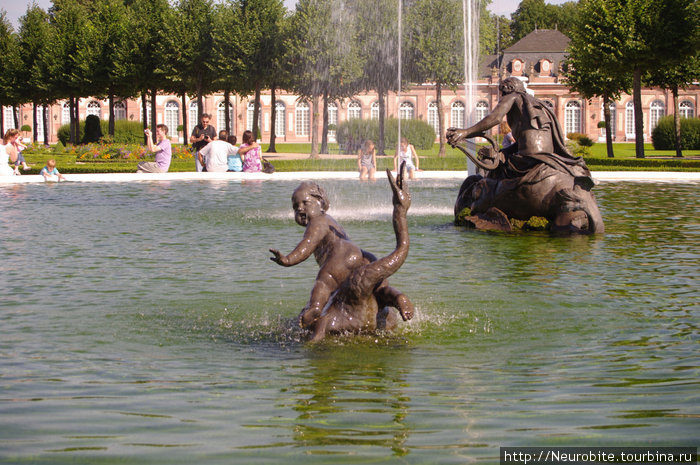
[566,0,632,158]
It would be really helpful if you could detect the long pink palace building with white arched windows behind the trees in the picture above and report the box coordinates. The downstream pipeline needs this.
[3,29,700,143]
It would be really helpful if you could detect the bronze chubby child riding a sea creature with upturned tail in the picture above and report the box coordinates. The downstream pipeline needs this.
[270,165,413,341]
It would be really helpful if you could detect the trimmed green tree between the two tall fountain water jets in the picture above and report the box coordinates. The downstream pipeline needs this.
[406,0,464,157]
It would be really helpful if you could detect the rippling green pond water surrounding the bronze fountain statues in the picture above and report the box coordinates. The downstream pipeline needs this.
[0,180,700,464]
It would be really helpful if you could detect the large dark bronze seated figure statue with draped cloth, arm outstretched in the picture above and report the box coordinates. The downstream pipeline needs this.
[447,77,604,233]
